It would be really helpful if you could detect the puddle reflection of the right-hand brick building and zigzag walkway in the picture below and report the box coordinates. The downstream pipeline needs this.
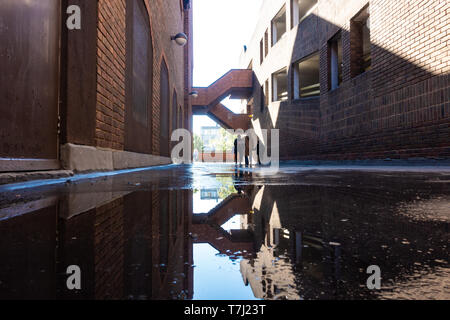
[192,173,450,299]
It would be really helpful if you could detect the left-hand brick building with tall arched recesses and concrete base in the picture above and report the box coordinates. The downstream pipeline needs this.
[0,0,193,172]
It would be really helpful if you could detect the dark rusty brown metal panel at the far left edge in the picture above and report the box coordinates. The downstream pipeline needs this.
[0,0,60,166]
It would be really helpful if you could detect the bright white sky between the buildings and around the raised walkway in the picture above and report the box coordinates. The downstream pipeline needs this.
[193,0,263,134]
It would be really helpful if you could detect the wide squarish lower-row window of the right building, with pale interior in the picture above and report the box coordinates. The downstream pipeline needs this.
[293,53,320,99]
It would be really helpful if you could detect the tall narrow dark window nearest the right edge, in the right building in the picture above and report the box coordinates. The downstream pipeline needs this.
[350,6,372,77]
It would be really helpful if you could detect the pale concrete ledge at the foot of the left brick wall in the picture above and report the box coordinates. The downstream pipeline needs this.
[61,143,172,172]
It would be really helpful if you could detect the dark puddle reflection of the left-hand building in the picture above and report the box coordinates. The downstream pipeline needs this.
[0,182,193,299]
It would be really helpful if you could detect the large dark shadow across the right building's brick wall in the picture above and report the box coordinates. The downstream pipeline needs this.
[253,14,450,160]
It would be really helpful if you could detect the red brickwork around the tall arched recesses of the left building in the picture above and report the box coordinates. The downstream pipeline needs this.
[95,0,192,155]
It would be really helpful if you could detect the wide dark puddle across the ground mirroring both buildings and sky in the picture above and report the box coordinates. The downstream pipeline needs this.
[0,168,450,300]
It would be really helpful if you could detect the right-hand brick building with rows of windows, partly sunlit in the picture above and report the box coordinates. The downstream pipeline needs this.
[241,0,450,159]
